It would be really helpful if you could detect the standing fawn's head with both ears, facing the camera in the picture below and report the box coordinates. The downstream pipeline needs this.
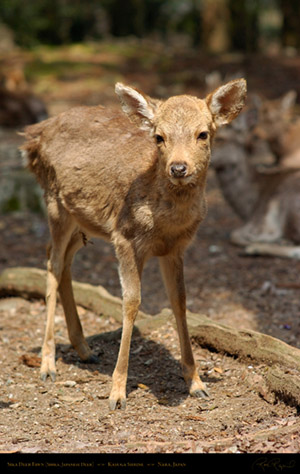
[116,79,246,186]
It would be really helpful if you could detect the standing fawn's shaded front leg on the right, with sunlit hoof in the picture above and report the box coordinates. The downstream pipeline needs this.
[159,255,208,398]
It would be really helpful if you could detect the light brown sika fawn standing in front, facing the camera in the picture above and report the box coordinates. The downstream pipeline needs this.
[22,79,246,410]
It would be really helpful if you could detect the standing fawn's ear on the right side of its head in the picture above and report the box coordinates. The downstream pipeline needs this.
[205,79,247,126]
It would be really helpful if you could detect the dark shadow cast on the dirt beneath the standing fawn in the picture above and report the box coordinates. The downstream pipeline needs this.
[31,327,220,407]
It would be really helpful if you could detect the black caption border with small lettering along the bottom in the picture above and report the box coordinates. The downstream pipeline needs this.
[0,453,300,474]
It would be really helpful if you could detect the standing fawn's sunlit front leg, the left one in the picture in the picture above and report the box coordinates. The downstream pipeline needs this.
[109,241,142,410]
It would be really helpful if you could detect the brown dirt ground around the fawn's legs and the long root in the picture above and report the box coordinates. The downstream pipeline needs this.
[0,42,300,454]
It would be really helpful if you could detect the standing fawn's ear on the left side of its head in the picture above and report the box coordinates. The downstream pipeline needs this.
[115,82,160,130]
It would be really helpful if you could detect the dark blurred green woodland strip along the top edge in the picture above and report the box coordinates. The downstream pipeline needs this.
[0,0,300,51]
